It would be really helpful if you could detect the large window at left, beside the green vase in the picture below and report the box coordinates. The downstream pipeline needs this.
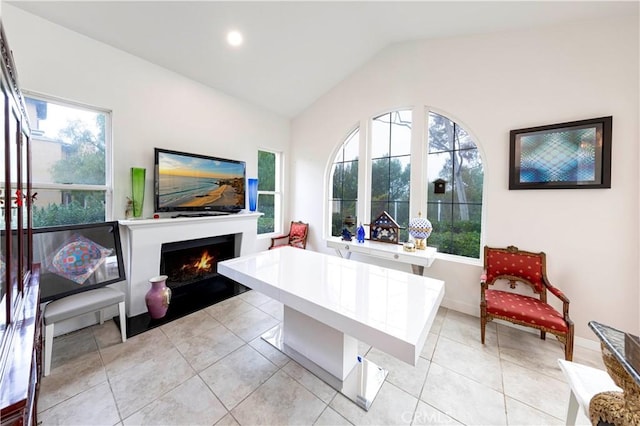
[25,95,111,227]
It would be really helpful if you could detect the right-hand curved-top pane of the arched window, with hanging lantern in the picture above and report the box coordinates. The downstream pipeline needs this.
[427,112,484,259]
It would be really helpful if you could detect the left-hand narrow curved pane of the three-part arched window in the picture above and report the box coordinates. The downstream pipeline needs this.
[331,129,360,236]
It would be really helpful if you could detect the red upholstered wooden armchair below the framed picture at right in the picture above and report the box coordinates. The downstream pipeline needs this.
[480,246,573,361]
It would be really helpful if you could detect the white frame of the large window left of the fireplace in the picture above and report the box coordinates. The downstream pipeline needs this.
[23,90,114,225]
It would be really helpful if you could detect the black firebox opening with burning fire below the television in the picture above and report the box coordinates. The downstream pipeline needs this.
[160,235,235,289]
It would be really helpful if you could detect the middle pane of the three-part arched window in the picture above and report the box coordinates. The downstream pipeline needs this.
[371,110,412,241]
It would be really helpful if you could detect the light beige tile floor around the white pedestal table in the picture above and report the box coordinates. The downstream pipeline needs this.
[38,291,604,425]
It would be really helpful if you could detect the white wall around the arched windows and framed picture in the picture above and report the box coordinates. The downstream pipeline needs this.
[290,16,640,340]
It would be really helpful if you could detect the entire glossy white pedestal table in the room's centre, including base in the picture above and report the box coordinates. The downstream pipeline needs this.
[218,247,444,409]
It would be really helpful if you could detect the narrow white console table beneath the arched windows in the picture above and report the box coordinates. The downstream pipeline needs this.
[327,237,438,275]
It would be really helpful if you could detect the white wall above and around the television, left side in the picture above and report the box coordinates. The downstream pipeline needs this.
[2,4,290,256]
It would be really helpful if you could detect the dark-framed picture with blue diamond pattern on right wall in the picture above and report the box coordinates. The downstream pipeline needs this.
[509,116,613,189]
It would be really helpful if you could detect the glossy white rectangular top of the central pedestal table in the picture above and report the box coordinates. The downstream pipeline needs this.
[218,247,444,365]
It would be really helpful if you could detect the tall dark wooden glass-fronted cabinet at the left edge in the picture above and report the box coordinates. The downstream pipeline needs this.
[0,22,42,426]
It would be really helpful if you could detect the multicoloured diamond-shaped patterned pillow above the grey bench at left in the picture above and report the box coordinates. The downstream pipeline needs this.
[47,234,112,285]
